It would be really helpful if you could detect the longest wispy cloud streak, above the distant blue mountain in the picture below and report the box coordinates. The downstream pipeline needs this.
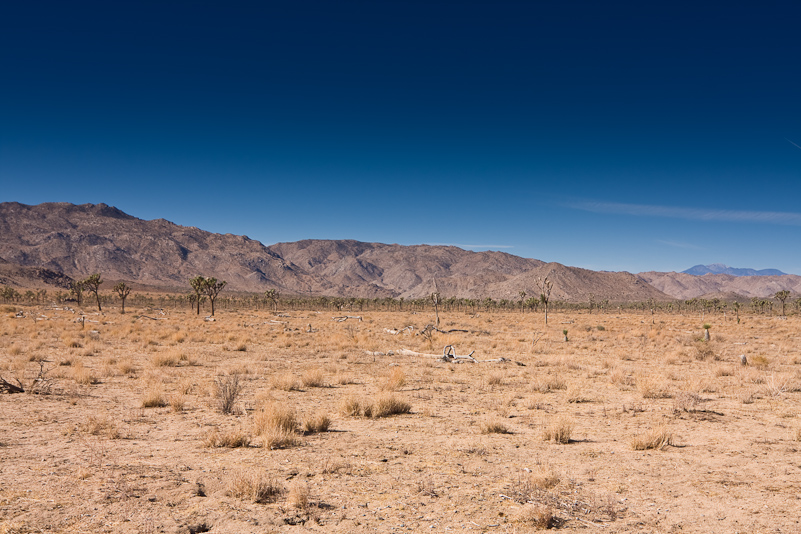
[568,202,801,226]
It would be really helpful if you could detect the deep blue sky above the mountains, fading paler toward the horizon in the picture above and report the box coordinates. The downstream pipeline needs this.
[0,0,801,274]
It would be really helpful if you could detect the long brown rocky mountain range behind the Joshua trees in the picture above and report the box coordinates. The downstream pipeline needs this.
[0,202,801,302]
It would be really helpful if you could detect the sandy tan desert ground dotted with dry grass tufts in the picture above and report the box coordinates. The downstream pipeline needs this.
[0,306,801,533]
